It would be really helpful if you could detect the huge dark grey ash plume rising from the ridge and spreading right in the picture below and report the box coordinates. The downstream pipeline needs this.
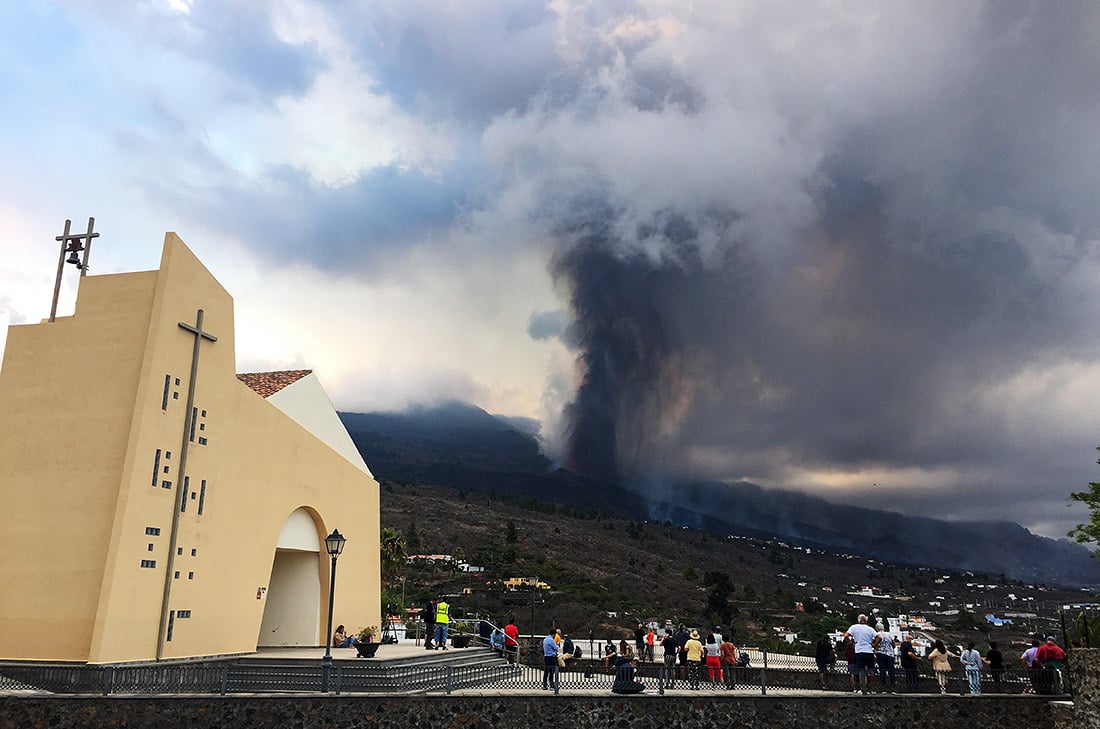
[486,3,1100,529]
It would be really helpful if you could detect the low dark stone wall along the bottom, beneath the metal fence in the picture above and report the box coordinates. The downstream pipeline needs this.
[0,693,1056,729]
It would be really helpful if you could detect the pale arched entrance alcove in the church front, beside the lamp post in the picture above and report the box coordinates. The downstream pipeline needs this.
[256,508,321,648]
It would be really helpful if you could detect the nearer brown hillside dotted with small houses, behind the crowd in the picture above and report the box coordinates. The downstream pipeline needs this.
[382,482,1081,649]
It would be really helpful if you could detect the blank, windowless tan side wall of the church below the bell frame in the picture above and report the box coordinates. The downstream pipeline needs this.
[0,273,155,660]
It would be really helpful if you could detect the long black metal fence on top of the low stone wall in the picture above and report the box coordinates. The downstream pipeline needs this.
[0,651,1071,695]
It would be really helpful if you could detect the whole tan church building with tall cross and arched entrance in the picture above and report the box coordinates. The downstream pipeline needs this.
[0,233,381,663]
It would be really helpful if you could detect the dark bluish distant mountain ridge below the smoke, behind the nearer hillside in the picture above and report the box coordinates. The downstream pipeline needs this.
[341,402,1100,588]
